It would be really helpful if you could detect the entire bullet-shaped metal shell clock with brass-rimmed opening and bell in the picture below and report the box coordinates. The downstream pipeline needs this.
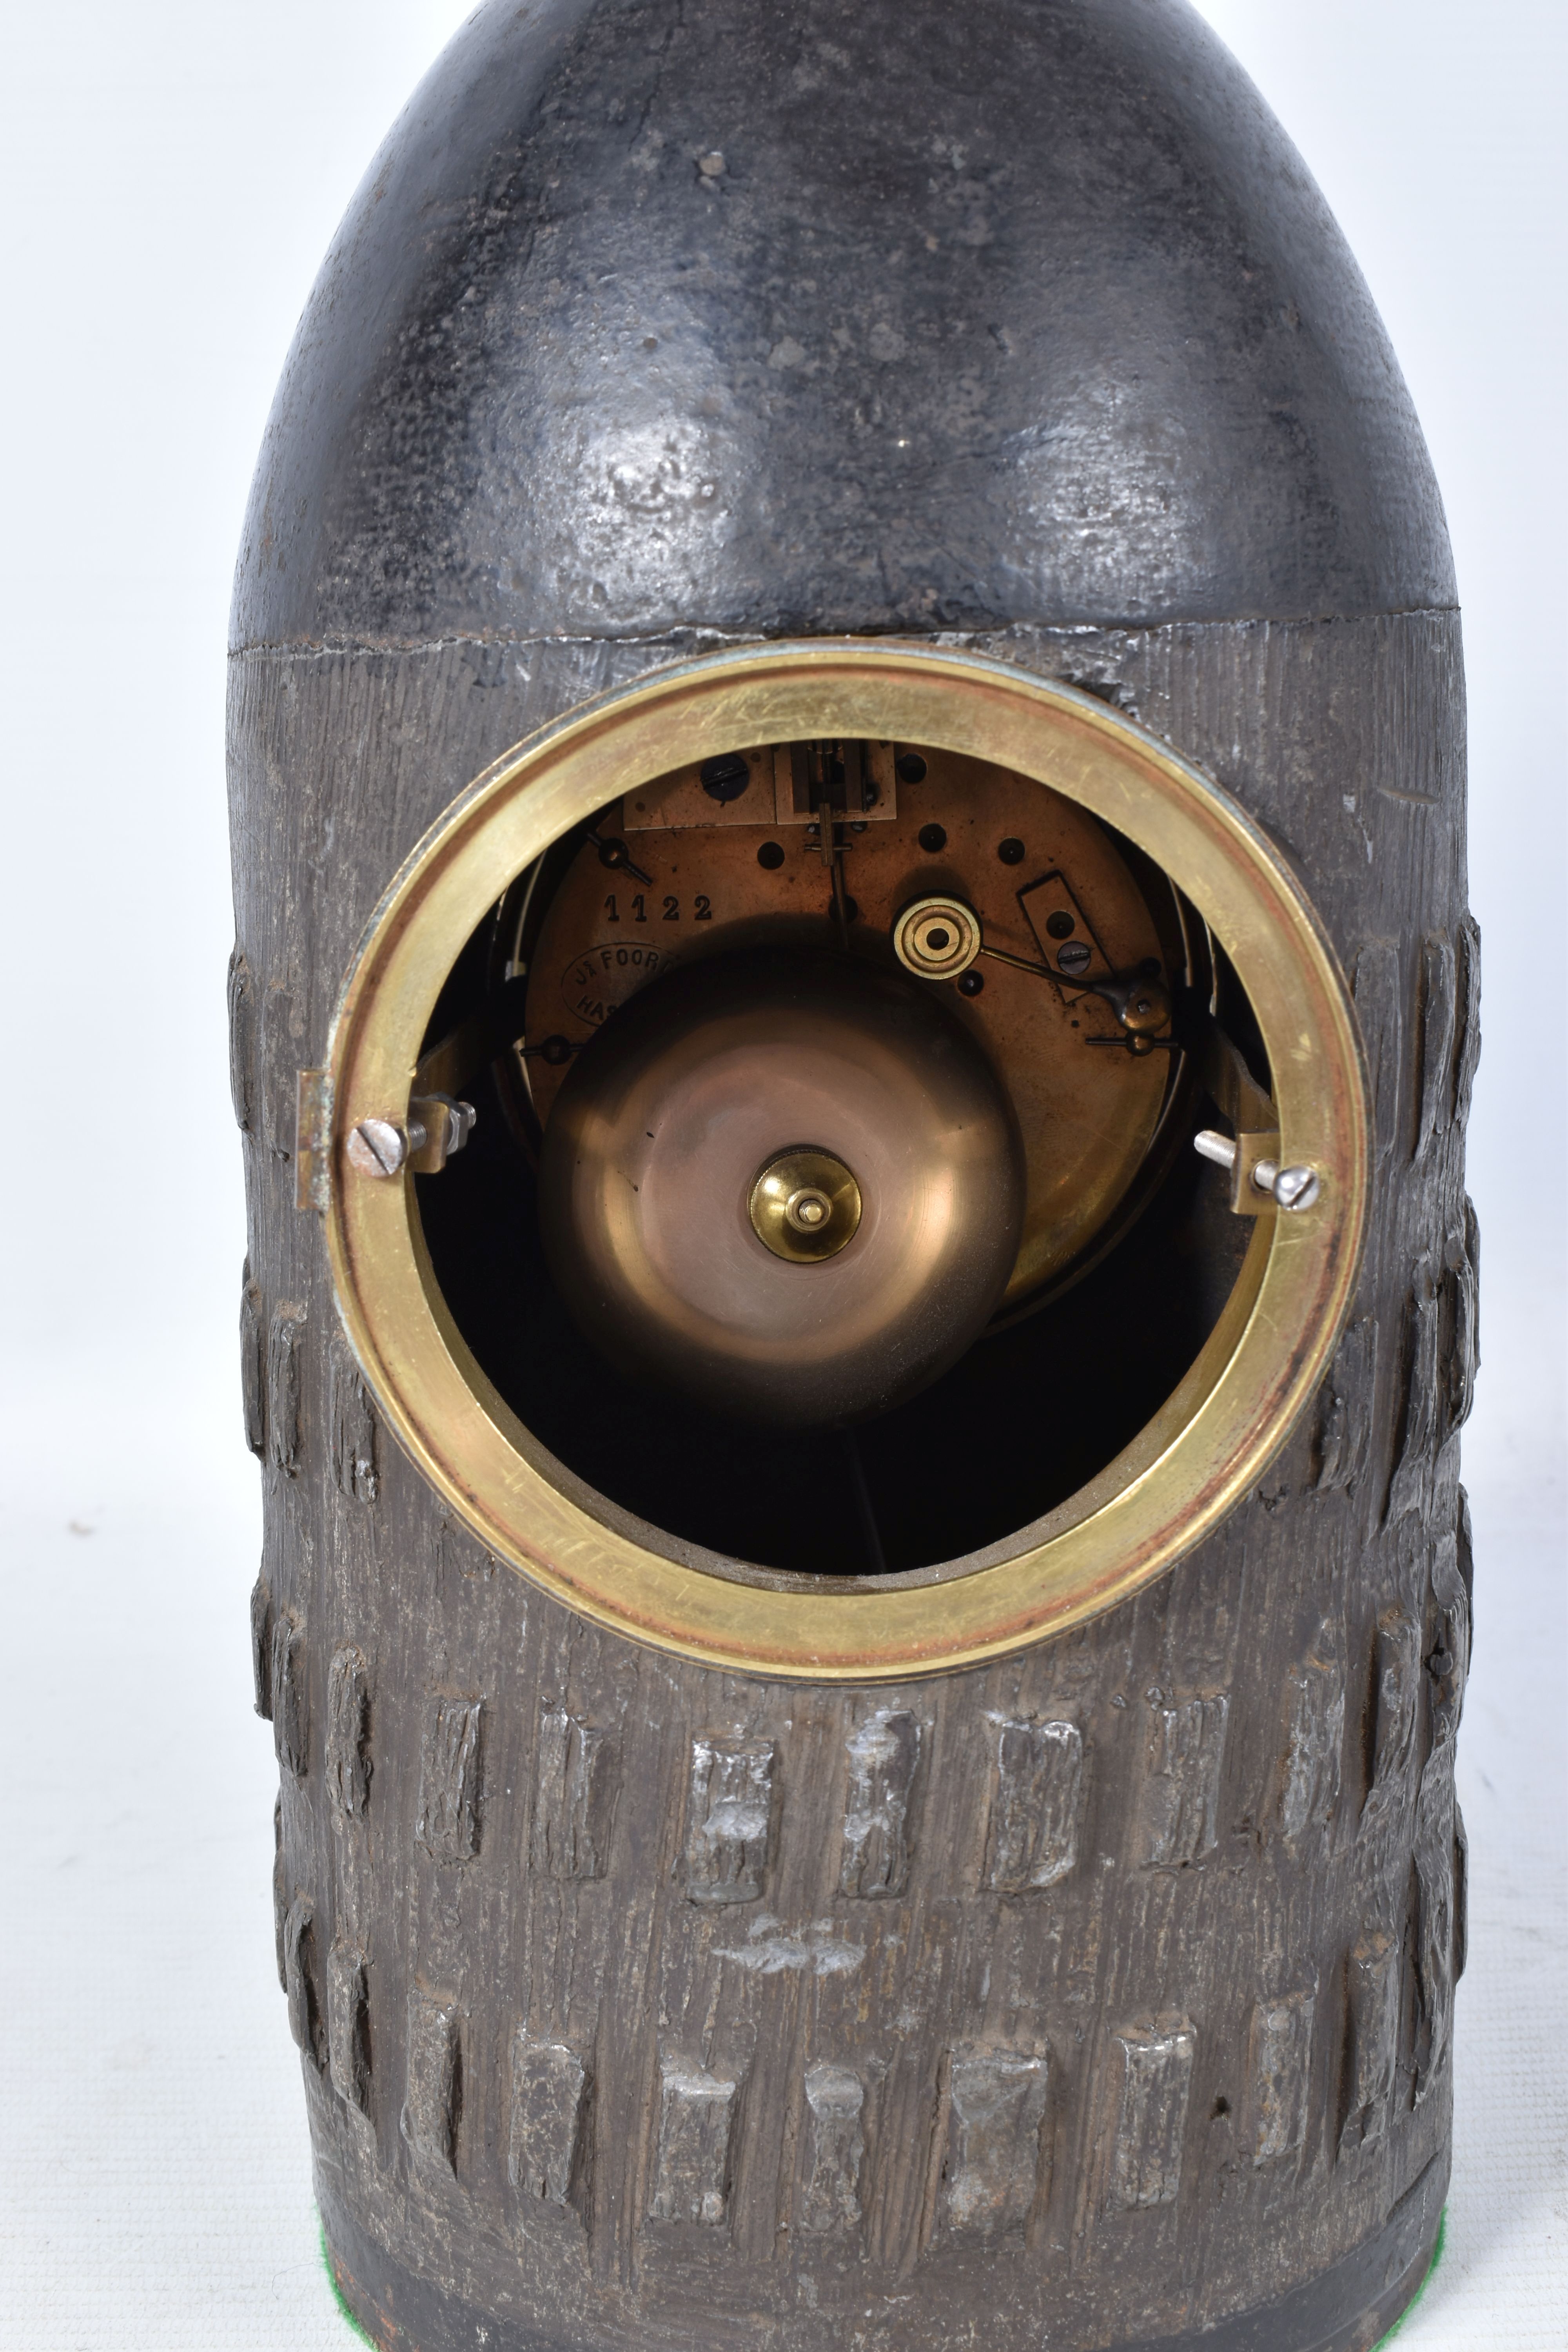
[230,0,1479,2352]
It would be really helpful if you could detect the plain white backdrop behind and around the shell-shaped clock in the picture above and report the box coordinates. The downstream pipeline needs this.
[0,0,1568,2352]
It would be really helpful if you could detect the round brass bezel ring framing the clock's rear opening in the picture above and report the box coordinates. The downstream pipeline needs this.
[325,637,1368,1682]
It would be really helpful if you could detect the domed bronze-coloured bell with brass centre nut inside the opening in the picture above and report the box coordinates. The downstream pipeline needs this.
[538,950,1025,1428]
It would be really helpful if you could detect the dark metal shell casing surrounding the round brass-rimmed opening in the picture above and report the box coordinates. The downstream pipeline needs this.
[230,0,1479,2352]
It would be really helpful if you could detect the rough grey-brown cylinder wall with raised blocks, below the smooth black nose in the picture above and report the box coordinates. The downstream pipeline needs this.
[238,616,1486,2352]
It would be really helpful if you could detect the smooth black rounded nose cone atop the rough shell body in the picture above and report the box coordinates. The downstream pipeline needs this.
[235,0,1453,644]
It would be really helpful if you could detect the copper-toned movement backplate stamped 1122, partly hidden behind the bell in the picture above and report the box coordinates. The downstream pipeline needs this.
[517,743,1173,1312]
